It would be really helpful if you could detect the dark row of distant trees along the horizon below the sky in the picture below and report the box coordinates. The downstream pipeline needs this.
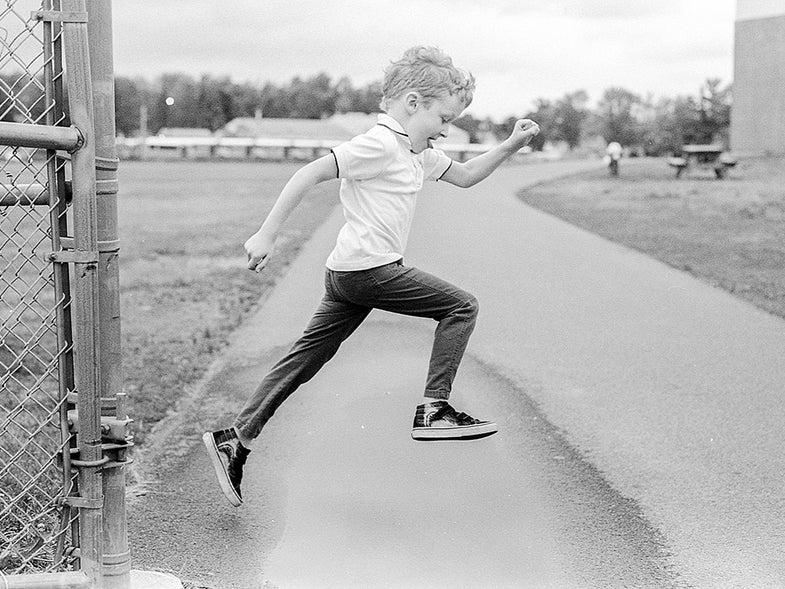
[0,73,732,155]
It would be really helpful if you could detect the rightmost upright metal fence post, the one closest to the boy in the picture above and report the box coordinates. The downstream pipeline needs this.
[87,0,131,589]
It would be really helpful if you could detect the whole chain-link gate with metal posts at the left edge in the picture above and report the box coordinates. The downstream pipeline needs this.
[0,0,125,589]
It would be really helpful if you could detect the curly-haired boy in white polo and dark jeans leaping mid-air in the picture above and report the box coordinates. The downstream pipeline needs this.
[203,47,539,506]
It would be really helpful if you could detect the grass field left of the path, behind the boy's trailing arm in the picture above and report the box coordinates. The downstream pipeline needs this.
[118,161,338,445]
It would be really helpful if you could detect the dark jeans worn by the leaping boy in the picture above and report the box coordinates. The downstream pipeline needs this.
[235,262,478,439]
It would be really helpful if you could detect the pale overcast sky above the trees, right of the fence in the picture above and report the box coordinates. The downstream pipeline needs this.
[113,0,736,119]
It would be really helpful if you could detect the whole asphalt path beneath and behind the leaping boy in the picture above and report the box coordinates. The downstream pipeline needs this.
[129,162,785,589]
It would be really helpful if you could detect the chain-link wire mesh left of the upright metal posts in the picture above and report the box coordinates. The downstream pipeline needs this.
[0,0,78,574]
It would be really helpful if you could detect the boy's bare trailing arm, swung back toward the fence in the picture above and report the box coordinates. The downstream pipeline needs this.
[244,155,337,272]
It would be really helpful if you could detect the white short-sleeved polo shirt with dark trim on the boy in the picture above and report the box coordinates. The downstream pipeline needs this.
[327,114,452,271]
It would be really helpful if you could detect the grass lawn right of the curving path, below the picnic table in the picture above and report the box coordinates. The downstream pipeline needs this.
[520,158,785,317]
